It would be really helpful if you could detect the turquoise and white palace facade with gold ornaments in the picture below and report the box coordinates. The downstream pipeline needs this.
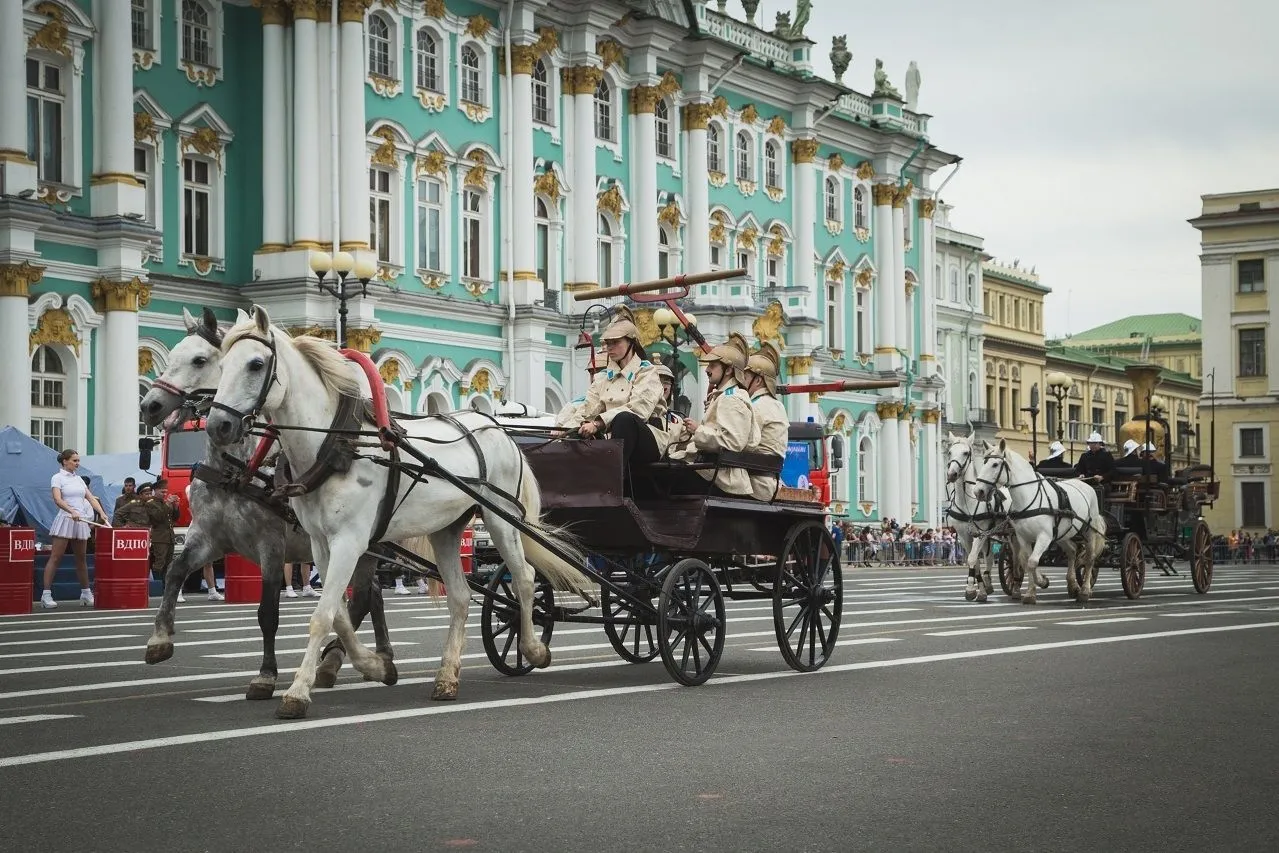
[0,0,957,524]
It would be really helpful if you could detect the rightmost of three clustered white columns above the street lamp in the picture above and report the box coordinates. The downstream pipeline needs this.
[337,10,368,252]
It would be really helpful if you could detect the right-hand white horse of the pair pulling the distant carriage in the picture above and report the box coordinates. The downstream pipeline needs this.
[973,439,1106,604]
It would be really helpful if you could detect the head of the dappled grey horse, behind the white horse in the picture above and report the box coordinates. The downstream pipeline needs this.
[141,307,248,428]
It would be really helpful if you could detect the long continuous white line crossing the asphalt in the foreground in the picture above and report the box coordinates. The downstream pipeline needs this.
[0,622,1279,767]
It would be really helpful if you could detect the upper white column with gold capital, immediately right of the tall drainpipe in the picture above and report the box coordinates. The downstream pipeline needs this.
[506,45,546,303]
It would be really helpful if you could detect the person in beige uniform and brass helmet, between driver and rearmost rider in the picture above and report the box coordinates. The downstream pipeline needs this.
[669,333,753,497]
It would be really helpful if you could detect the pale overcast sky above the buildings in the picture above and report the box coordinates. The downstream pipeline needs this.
[746,0,1279,336]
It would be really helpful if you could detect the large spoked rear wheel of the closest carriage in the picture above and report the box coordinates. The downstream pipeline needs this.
[773,522,844,673]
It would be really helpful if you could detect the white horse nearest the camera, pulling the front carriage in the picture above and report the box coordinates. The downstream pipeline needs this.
[206,306,590,719]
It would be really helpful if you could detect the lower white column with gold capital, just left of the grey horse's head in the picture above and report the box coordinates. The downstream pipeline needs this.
[92,278,151,453]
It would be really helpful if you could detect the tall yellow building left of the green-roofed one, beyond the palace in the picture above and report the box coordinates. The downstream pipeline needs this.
[981,261,1051,457]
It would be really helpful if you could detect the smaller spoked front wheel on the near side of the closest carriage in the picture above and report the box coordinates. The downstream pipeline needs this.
[657,560,724,687]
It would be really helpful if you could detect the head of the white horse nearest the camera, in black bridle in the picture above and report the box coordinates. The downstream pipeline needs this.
[205,306,284,446]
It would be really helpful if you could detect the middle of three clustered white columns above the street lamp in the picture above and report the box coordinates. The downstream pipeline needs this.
[292,4,319,248]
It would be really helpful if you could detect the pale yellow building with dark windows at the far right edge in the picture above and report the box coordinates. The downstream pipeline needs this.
[1189,189,1279,532]
